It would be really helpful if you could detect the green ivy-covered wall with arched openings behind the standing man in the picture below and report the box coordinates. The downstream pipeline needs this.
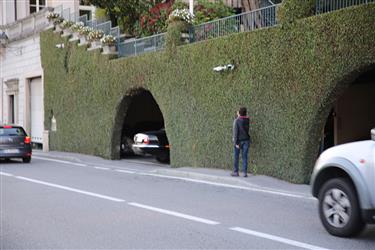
[41,4,375,183]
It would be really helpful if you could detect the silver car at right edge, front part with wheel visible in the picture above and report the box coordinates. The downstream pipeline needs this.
[311,128,375,237]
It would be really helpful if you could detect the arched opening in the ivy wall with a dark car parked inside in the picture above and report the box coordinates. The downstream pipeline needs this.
[118,88,169,162]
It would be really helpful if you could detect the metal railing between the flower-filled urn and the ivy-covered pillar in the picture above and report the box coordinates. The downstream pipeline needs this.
[190,5,279,42]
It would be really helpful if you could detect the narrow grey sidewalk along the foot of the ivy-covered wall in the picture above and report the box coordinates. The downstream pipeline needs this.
[33,150,311,197]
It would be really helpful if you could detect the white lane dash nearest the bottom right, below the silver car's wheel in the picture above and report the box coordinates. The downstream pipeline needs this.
[229,227,328,250]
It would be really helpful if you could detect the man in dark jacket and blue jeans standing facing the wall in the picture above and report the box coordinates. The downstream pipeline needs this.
[231,107,250,177]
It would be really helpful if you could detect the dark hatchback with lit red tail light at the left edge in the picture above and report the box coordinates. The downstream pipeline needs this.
[0,125,32,163]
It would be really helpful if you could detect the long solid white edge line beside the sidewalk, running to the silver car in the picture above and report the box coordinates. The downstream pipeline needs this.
[139,173,315,200]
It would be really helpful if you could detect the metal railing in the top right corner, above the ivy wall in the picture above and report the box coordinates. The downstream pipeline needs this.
[316,0,375,14]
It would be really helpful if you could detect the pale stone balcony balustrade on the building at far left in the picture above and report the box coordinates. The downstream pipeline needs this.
[0,8,51,42]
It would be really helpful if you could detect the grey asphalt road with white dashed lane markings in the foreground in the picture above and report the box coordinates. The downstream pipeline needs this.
[0,156,375,249]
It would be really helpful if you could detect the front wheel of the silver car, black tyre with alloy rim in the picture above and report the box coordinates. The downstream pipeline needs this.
[319,178,365,237]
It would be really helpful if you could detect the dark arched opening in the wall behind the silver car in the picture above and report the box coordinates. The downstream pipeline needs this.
[320,68,375,153]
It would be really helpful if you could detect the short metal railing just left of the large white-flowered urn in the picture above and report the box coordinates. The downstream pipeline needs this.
[118,33,165,57]
